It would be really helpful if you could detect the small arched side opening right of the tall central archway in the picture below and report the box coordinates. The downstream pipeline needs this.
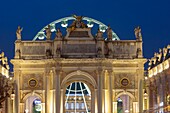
[117,94,133,113]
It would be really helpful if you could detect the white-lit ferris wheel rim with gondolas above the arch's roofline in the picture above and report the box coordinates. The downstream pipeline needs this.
[33,16,120,41]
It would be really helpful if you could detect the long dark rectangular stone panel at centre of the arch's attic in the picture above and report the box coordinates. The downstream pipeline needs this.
[63,44,96,53]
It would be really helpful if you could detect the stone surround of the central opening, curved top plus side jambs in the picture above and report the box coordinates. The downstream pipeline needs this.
[61,70,97,113]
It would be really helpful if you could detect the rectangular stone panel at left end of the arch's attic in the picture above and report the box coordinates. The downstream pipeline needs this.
[22,46,45,55]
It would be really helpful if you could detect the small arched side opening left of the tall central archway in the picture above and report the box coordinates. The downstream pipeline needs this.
[24,96,42,113]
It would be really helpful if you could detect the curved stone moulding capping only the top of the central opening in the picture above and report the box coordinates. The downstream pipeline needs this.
[61,70,97,89]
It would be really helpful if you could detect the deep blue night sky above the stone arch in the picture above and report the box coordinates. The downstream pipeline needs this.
[0,0,170,70]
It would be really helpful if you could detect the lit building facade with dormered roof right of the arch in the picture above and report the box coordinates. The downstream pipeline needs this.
[146,45,170,113]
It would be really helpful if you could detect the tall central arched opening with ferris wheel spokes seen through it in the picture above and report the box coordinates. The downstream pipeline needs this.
[65,81,91,113]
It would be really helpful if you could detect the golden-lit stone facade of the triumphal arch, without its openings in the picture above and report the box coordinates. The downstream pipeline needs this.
[11,16,146,113]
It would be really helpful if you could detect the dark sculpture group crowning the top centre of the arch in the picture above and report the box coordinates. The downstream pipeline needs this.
[70,15,87,31]
